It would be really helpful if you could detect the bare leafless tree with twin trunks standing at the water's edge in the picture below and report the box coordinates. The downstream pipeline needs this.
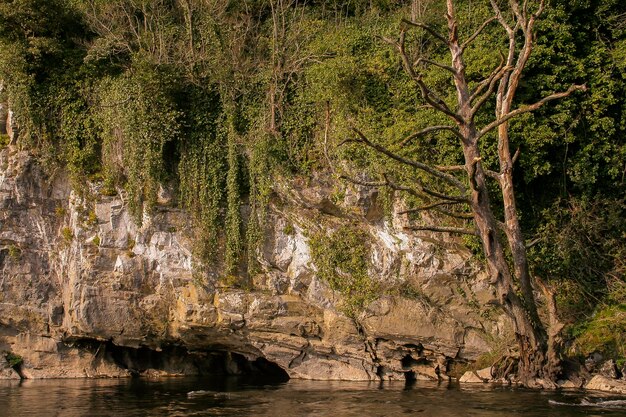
[350,0,586,386]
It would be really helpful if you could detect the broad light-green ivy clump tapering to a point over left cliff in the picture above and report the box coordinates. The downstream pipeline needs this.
[97,64,182,218]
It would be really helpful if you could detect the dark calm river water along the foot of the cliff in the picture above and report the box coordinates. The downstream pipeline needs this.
[0,378,626,417]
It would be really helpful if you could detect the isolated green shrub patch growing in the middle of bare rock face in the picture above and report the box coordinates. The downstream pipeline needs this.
[310,225,378,317]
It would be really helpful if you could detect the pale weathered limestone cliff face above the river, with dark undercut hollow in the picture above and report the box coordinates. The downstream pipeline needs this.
[0,146,510,380]
